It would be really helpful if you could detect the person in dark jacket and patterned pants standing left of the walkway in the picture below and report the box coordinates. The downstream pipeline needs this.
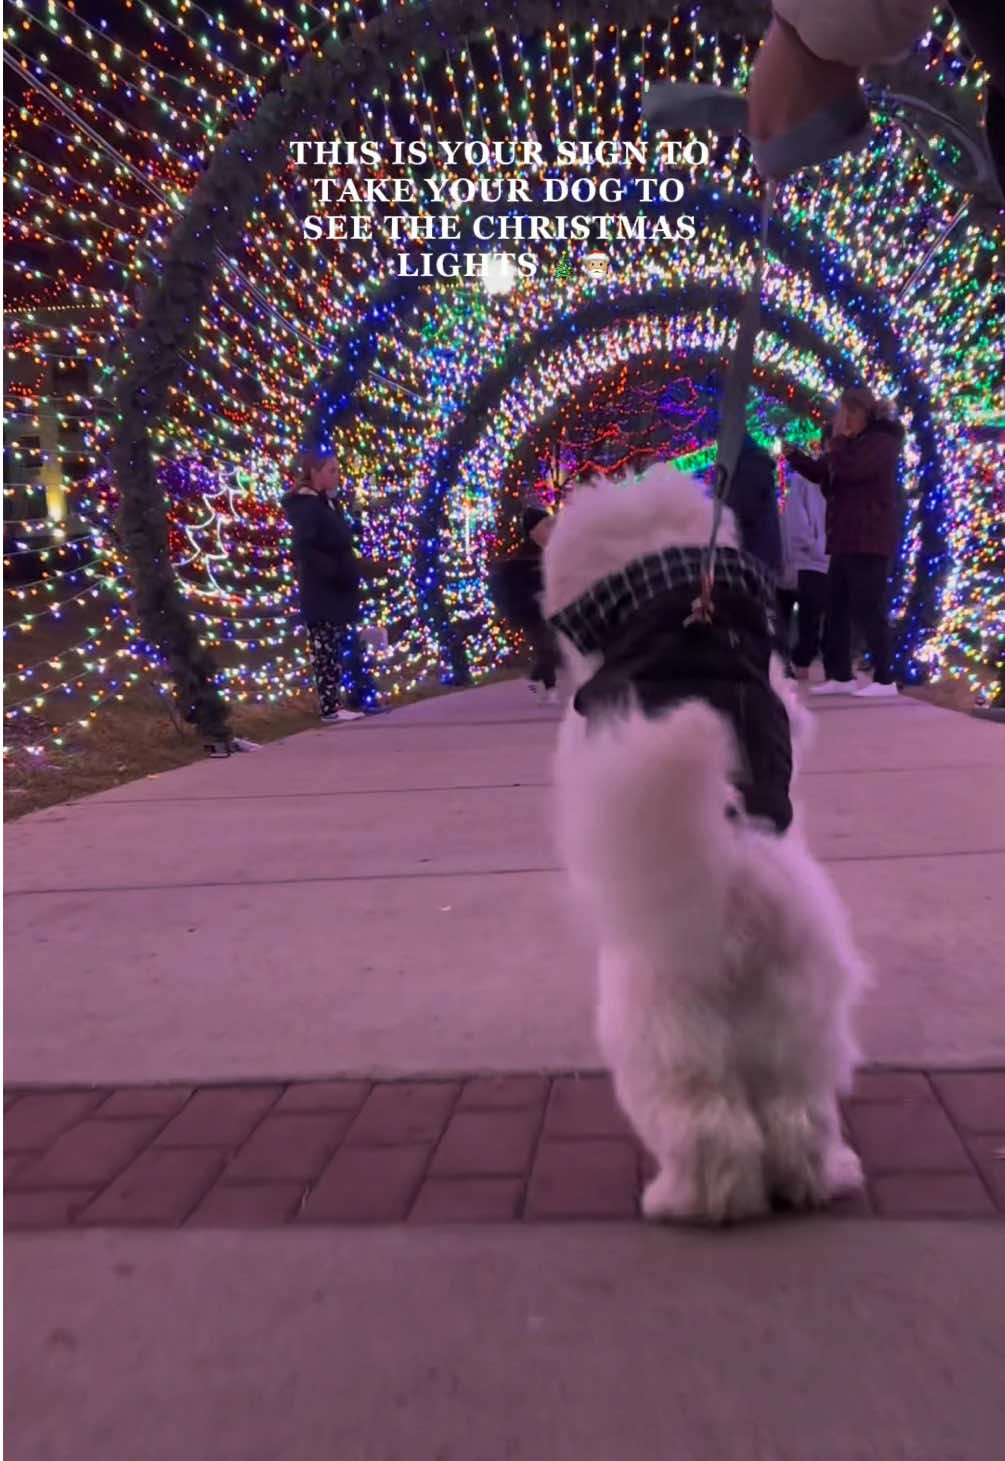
[283,451,365,725]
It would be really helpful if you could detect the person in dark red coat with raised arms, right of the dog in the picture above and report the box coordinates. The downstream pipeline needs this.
[784,386,904,698]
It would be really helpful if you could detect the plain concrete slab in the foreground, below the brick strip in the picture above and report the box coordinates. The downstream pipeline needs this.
[7,1221,1005,1461]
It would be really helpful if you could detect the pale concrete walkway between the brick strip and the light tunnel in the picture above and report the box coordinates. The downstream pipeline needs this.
[6,684,1005,1084]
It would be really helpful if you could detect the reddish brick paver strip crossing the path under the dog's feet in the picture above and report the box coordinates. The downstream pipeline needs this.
[4,1069,1005,1229]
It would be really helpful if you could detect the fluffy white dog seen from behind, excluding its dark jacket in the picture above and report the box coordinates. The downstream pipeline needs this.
[543,466,863,1221]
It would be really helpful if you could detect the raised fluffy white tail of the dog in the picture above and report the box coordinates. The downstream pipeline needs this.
[557,700,738,925]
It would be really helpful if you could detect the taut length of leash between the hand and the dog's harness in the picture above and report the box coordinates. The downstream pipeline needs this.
[684,178,777,628]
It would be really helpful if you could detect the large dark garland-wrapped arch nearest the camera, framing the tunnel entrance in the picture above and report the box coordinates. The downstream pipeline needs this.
[111,0,993,739]
